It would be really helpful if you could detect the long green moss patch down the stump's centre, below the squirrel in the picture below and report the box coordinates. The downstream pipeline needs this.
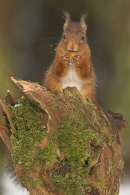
[53,109,102,195]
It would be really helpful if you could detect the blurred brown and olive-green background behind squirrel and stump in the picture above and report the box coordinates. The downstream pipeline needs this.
[0,0,130,195]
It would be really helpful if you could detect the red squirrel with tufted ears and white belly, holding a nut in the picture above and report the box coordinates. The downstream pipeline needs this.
[44,12,95,100]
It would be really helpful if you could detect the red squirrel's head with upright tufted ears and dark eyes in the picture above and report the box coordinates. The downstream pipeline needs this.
[55,12,88,53]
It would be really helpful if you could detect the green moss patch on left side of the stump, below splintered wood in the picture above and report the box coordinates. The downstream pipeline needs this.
[9,97,57,186]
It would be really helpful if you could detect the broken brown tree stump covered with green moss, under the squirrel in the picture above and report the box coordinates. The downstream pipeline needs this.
[0,78,127,195]
